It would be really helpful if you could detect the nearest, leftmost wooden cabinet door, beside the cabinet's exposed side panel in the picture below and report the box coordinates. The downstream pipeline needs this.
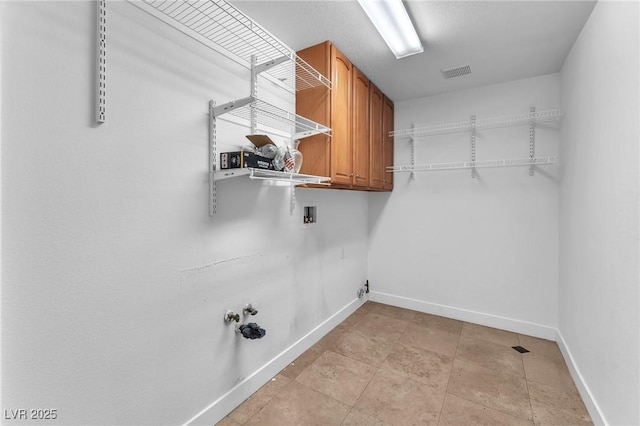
[331,45,353,185]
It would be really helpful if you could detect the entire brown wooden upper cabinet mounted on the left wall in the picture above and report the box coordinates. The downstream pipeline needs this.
[296,41,393,191]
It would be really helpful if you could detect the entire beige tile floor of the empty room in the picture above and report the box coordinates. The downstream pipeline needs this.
[218,302,592,426]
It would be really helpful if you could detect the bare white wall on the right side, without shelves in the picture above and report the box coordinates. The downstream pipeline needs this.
[559,2,640,425]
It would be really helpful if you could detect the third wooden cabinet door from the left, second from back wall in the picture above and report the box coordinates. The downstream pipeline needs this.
[369,83,385,190]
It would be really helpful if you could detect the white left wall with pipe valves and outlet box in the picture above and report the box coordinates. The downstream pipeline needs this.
[0,2,368,425]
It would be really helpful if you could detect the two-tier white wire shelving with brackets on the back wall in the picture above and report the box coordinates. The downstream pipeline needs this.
[387,106,563,180]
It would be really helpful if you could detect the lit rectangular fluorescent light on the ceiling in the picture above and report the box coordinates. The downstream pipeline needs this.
[358,0,424,59]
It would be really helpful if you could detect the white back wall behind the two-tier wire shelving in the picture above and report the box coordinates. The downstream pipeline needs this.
[369,74,559,338]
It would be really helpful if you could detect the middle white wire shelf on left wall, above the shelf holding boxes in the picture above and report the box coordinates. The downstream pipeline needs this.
[214,96,331,139]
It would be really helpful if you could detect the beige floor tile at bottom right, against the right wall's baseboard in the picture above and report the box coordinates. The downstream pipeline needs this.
[529,382,593,425]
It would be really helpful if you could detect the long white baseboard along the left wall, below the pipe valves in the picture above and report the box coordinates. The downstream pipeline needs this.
[185,299,366,426]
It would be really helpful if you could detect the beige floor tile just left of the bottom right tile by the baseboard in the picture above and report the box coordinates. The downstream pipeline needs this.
[447,359,532,420]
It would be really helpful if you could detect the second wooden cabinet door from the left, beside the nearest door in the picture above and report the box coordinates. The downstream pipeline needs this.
[352,67,369,188]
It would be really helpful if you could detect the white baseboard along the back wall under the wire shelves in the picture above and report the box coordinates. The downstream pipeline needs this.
[369,291,556,340]
